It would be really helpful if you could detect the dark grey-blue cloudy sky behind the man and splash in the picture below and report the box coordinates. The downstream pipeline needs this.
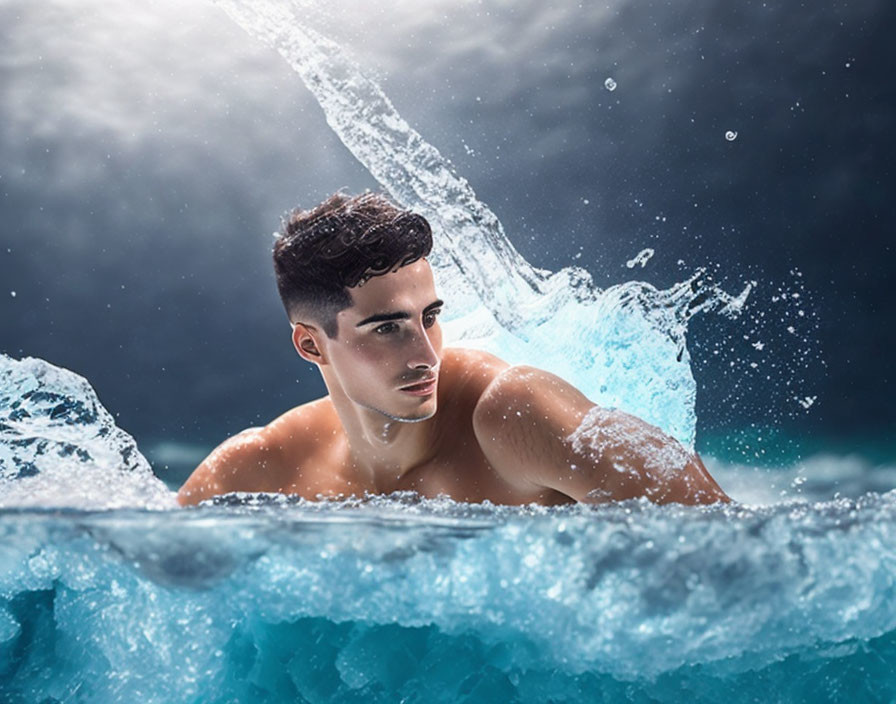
[0,0,896,478]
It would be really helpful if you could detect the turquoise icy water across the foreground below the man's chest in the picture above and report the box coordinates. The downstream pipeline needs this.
[0,494,896,702]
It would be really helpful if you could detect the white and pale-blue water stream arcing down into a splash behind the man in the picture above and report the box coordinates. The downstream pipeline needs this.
[210,0,750,447]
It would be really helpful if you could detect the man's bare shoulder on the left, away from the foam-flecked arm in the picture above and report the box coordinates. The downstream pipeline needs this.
[177,398,338,505]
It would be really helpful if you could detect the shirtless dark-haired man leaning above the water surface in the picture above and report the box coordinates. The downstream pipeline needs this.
[177,193,730,505]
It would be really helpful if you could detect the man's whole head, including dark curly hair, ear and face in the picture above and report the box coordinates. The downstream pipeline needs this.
[274,194,442,421]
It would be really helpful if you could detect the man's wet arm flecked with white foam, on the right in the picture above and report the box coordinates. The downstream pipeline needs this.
[473,367,728,503]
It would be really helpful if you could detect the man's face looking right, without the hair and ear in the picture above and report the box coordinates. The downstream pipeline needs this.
[326,259,442,421]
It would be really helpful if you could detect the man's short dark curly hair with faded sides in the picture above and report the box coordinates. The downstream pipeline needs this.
[274,193,432,338]
